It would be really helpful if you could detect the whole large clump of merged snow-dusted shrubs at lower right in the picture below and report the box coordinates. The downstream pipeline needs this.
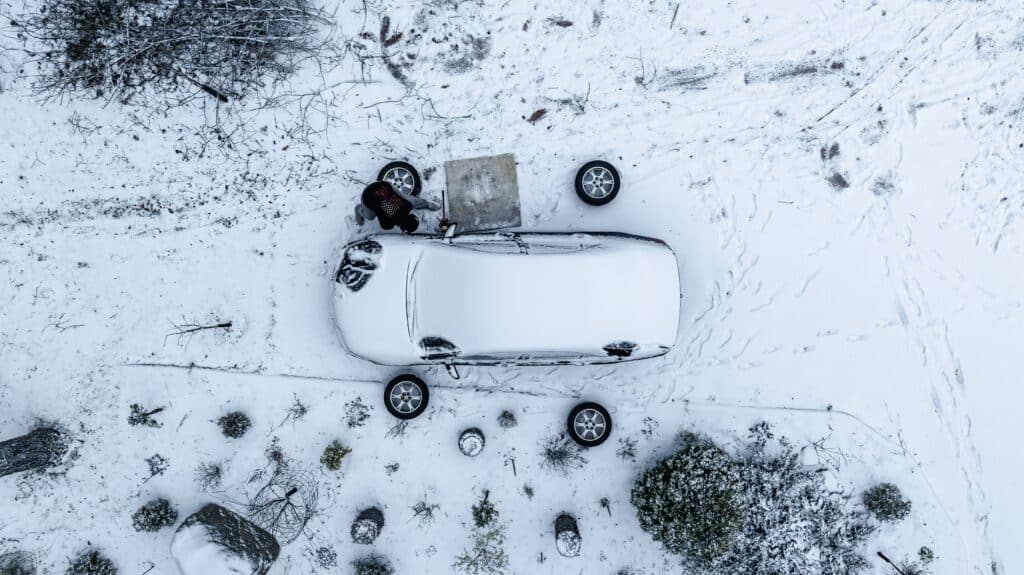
[633,424,873,575]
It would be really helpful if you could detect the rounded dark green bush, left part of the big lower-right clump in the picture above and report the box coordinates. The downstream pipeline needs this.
[631,434,743,563]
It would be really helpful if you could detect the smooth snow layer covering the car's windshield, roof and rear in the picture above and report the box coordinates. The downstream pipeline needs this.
[410,235,679,358]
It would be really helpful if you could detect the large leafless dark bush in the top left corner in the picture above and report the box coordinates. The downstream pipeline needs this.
[22,0,328,101]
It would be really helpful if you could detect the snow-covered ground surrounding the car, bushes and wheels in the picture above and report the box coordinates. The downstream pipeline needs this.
[0,0,1024,575]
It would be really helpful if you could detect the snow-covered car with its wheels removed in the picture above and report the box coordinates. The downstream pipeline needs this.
[334,229,680,367]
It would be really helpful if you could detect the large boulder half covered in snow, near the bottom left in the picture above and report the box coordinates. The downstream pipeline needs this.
[171,503,281,575]
